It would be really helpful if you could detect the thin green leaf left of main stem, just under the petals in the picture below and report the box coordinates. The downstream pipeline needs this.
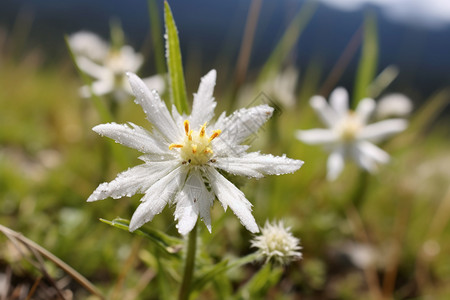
[100,218,183,258]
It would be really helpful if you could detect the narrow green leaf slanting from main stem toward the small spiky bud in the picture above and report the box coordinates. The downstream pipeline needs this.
[191,253,257,291]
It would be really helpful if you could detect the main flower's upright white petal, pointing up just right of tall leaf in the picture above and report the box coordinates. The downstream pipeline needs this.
[190,70,217,129]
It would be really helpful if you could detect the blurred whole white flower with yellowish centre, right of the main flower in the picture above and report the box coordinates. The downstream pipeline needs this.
[296,88,408,180]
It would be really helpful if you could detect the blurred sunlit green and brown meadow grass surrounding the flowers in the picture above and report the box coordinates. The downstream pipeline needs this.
[0,1,450,299]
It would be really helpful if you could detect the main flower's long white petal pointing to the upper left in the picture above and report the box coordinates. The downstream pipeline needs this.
[127,73,183,143]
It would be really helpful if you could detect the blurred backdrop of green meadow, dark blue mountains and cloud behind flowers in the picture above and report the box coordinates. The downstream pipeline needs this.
[0,0,450,300]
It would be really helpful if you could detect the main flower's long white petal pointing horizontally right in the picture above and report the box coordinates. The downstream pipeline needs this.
[214,152,303,178]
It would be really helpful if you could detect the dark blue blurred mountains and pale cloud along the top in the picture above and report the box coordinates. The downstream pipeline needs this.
[0,0,450,100]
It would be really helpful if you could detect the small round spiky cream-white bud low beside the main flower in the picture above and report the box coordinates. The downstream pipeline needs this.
[251,221,302,265]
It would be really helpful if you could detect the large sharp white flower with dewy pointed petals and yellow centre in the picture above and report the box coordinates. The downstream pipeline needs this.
[88,70,303,235]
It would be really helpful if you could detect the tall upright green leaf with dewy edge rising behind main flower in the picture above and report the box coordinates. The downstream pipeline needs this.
[164,1,189,113]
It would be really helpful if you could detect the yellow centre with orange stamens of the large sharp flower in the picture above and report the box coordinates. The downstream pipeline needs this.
[169,120,222,165]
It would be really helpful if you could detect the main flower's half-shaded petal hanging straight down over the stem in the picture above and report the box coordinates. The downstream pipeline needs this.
[175,171,214,235]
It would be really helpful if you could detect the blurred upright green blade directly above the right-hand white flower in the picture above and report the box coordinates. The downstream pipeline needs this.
[353,14,378,108]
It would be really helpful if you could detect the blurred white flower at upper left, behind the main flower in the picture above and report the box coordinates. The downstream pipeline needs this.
[68,32,164,101]
